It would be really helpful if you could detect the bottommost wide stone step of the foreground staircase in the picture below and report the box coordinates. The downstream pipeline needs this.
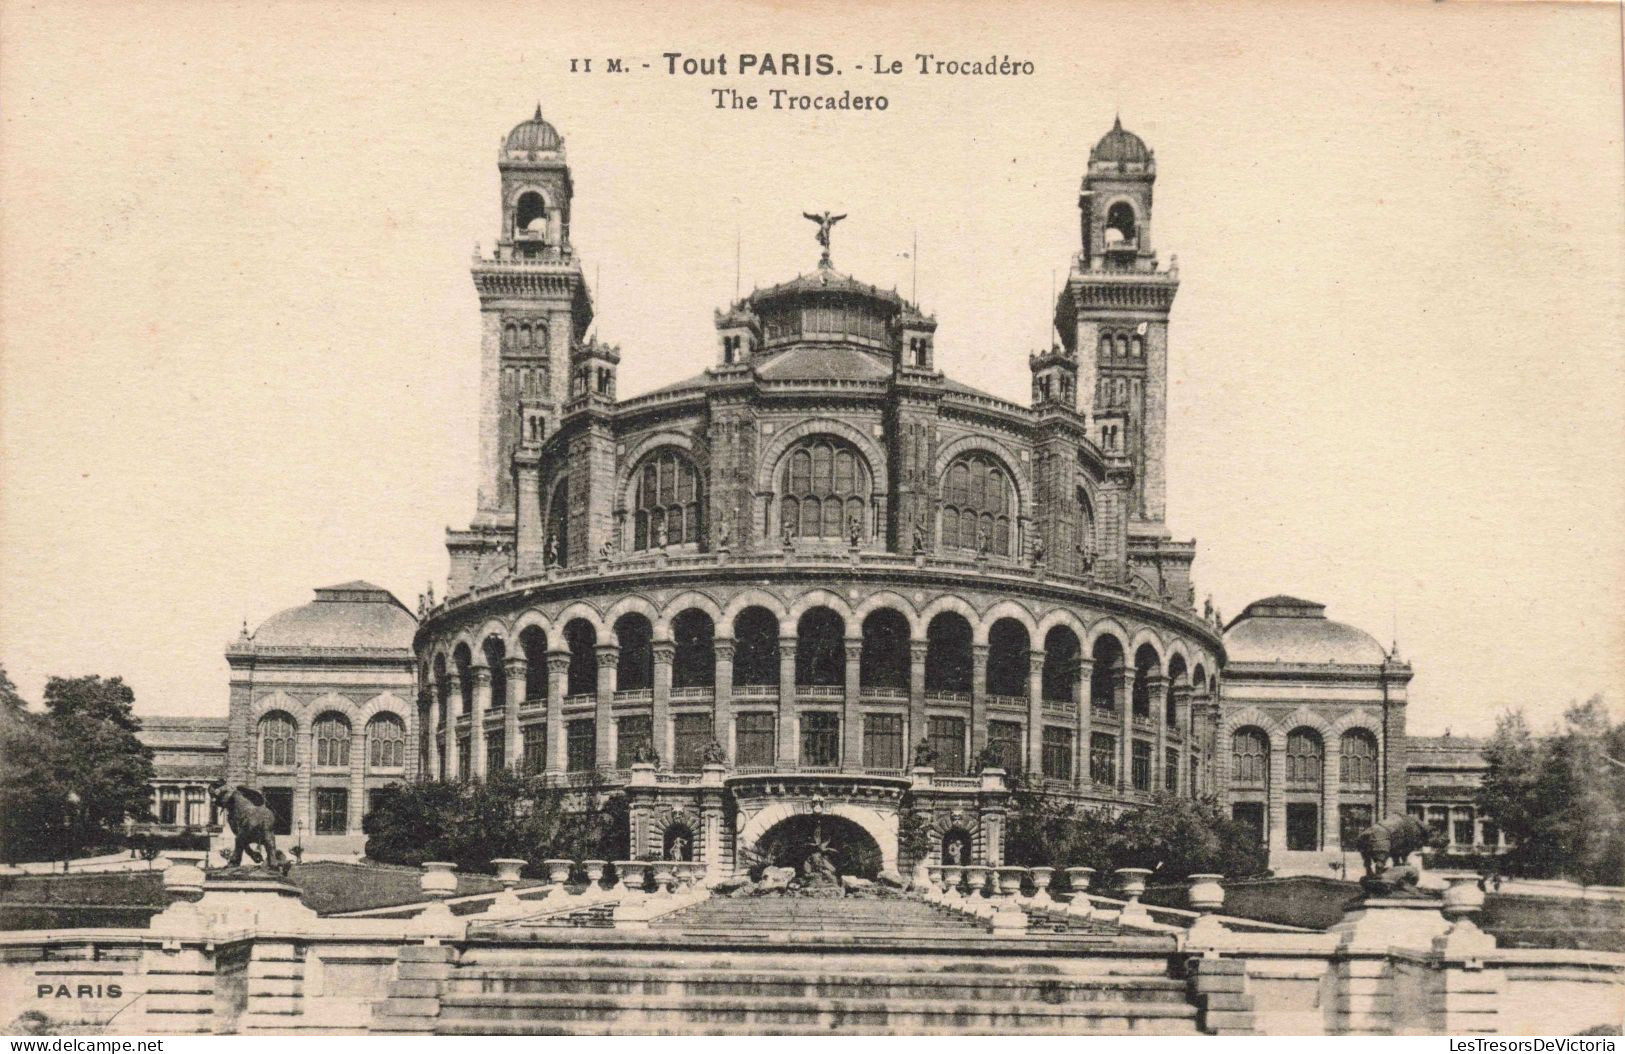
[437,994,1196,1035]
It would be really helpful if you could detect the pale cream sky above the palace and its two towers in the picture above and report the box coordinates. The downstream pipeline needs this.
[0,0,1625,734]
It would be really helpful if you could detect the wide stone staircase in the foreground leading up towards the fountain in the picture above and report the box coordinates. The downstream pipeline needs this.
[416,896,1196,1035]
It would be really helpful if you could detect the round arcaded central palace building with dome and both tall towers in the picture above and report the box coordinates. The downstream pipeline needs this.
[403,110,1397,877]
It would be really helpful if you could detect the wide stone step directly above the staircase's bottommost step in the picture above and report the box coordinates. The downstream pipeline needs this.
[449,965,1185,1005]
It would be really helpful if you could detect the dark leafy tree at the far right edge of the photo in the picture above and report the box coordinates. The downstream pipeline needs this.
[1477,695,1625,883]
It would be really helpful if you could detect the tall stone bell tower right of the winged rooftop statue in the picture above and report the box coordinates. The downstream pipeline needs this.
[1055,120,1180,526]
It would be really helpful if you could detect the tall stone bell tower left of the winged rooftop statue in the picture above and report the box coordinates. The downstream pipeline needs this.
[473,106,593,531]
